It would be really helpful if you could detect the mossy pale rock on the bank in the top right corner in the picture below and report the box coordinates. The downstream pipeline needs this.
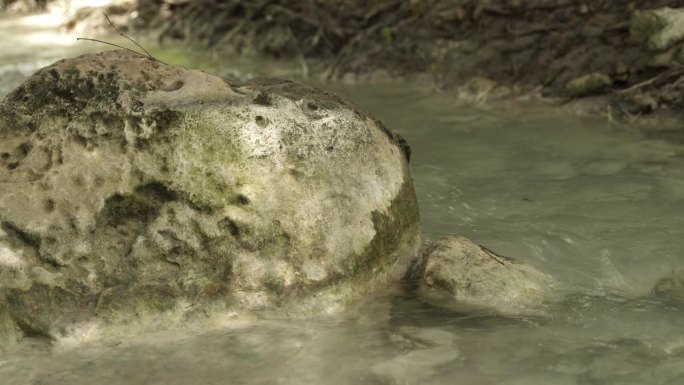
[630,7,684,51]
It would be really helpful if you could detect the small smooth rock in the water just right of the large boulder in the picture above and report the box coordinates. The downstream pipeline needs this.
[421,237,553,315]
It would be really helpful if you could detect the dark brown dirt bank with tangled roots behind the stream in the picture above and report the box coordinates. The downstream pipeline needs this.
[6,0,684,121]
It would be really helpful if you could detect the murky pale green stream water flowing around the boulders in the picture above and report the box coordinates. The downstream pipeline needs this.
[0,9,684,385]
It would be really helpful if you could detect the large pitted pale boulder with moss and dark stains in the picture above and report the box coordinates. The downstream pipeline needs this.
[0,50,420,340]
